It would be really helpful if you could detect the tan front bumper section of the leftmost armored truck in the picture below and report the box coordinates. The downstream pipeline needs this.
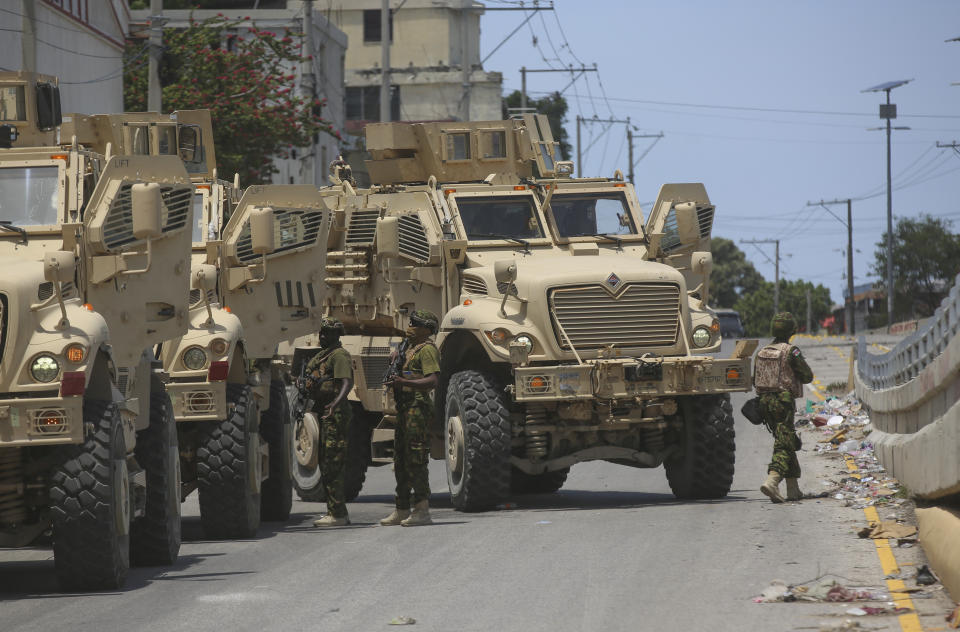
[0,395,83,448]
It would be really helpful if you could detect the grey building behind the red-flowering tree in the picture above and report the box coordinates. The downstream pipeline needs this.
[130,1,347,186]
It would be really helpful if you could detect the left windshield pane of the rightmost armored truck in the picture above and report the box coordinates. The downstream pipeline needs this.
[456,195,543,241]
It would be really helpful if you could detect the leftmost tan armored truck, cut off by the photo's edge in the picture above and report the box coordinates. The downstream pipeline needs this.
[0,73,193,590]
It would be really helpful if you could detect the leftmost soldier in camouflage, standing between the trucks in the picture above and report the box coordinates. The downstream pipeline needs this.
[306,318,353,527]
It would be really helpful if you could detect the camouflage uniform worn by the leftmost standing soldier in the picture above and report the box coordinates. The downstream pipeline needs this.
[306,330,353,518]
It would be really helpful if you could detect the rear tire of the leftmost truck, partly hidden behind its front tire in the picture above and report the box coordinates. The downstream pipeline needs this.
[130,388,180,566]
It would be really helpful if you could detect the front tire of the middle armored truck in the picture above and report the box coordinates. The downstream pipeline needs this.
[197,384,260,539]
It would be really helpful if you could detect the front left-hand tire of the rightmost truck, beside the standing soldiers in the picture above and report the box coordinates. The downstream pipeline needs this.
[444,371,511,511]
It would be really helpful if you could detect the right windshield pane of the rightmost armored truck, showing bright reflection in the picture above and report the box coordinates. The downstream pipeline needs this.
[550,192,637,237]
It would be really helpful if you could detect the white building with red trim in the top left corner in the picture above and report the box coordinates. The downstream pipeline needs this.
[0,0,130,113]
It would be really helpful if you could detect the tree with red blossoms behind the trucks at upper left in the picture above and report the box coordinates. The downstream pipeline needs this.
[123,15,340,185]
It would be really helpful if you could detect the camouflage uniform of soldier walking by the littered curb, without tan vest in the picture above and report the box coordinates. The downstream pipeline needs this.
[759,312,813,479]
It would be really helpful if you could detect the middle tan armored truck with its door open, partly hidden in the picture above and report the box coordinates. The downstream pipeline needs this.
[65,111,330,538]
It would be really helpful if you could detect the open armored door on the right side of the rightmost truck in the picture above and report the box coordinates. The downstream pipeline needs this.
[645,182,714,299]
